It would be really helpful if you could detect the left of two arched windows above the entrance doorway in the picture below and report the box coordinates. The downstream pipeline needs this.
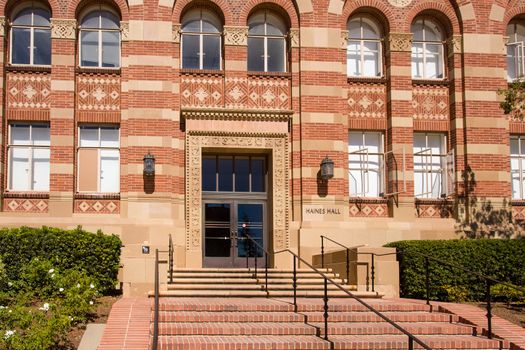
[181,8,222,69]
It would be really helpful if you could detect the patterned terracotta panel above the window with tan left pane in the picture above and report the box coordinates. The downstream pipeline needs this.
[77,74,121,112]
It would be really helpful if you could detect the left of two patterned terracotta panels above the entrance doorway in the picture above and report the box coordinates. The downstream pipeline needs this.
[180,74,224,108]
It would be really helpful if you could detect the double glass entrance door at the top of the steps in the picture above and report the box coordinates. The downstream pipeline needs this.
[203,200,267,267]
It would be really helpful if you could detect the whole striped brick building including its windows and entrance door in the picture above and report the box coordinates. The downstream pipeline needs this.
[0,0,525,293]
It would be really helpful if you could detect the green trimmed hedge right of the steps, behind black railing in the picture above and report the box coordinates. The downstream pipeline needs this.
[386,239,525,301]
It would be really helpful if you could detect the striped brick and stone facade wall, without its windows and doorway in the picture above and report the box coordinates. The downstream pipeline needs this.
[0,0,525,294]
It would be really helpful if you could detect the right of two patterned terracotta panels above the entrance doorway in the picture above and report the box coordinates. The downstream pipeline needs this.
[247,76,291,110]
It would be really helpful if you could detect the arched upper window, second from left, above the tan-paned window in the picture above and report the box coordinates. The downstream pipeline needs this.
[80,7,120,68]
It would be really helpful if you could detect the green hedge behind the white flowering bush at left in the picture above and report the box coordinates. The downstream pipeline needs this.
[0,227,122,293]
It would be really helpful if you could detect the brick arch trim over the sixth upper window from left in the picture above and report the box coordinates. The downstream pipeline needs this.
[404,1,461,37]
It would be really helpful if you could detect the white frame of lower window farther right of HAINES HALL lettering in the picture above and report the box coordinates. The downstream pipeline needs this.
[414,132,455,199]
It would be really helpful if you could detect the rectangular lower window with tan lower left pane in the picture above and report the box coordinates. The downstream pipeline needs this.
[78,126,120,193]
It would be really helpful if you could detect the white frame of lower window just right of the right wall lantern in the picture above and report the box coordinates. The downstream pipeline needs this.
[348,130,386,198]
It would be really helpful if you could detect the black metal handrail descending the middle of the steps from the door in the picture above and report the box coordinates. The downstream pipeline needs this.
[246,235,432,350]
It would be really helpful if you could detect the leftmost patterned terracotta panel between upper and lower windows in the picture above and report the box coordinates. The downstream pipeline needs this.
[6,72,51,110]
